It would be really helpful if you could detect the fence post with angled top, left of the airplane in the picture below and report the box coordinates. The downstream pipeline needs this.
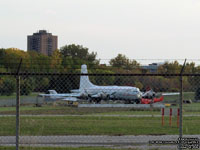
[16,59,22,150]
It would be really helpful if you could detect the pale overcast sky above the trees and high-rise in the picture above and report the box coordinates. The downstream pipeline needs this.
[0,0,200,63]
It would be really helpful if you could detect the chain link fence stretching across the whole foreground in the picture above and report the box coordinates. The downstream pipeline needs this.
[0,60,200,150]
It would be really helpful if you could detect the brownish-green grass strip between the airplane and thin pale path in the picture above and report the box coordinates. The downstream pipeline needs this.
[0,103,200,115]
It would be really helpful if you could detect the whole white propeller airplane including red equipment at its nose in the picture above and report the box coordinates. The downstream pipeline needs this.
[39,64,177,104]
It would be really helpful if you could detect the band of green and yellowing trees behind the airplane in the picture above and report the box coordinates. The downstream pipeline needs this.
[0,44,200,97]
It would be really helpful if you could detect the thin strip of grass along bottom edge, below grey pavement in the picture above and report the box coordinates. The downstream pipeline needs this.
[0,146,159,150]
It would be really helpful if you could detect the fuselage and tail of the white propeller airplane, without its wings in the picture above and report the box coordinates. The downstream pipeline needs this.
[79,64,142,103]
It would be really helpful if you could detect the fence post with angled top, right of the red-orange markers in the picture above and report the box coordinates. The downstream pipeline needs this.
[179,59,186,150]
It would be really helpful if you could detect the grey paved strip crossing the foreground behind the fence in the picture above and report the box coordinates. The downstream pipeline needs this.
[0,135,200,149]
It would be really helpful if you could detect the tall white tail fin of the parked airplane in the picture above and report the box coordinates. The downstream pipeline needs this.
[79,64,94,90]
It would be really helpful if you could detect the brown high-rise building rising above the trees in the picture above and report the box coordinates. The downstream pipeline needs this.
[27,30,58,56]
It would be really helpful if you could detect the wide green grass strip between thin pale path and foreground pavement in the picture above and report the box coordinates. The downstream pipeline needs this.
[0,116,200,136]
